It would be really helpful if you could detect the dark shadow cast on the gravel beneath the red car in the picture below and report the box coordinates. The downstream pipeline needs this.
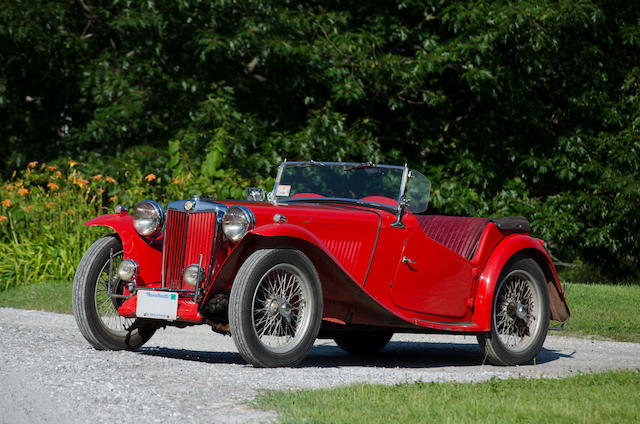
[138,341,572,368]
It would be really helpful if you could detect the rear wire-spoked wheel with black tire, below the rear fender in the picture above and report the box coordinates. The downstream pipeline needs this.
[478,255,550,365]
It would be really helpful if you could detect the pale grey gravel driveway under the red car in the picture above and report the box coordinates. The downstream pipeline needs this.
[0,308,640,424]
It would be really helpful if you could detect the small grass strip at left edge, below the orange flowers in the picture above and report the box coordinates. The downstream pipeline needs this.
[0,281,73,314]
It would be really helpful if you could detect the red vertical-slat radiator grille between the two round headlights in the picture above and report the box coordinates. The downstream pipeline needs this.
[162,209,216,290]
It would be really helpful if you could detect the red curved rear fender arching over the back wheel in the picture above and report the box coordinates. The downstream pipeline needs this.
[472,234,570,331]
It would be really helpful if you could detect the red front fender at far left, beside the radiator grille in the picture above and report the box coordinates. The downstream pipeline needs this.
[84,214,162,285]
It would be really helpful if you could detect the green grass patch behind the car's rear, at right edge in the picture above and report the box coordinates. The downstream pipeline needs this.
[551,284,640,343]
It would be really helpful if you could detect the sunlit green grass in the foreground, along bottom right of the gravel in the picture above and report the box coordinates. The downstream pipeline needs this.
[255,370,640,424]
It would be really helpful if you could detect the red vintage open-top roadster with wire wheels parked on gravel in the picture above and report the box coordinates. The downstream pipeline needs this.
[73,161,569,367]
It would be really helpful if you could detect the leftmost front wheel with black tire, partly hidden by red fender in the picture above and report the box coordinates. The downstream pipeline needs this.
[72,235,155,350]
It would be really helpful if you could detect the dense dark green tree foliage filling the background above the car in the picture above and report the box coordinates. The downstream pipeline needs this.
[0,0,640,278]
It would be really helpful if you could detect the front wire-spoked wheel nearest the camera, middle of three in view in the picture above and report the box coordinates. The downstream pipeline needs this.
[229,249,322,367]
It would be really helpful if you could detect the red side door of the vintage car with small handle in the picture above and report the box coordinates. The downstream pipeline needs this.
[391,230,473,318]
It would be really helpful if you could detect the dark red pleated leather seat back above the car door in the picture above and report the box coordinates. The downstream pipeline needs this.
[415,215,491,260]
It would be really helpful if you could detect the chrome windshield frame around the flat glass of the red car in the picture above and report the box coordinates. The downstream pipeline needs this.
[268,159,426,217]
